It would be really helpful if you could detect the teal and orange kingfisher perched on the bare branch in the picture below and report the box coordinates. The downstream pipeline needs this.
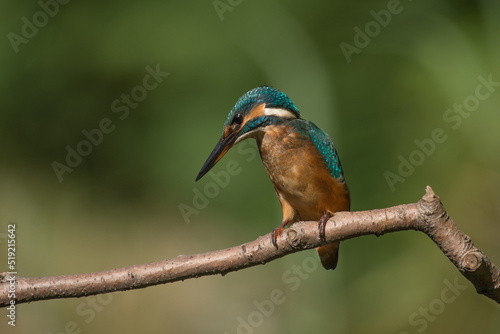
[196,86,350,269]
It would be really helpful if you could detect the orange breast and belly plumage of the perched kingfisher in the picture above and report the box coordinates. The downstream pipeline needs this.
[258,124,350,220]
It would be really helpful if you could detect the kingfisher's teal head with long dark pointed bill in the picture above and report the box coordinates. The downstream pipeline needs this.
[196,86,300,181]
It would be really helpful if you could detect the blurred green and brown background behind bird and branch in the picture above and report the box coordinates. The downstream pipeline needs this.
[0,0,500,334]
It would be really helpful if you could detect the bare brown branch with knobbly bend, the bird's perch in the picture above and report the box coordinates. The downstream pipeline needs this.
[0,186,500,307]
